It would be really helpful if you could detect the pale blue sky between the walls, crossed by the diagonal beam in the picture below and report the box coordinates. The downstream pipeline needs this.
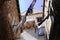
[19,0,43,12]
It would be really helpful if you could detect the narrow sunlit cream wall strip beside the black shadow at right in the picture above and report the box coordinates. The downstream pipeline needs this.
[44,0,51,39]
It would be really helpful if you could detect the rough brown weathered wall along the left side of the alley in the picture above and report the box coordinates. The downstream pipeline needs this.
[0,0,19,40]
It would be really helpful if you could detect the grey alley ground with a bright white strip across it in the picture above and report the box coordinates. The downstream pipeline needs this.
[21,29,46,40]
